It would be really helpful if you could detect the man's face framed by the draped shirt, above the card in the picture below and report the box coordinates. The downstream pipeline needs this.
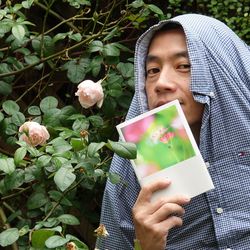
[146,29,204,128]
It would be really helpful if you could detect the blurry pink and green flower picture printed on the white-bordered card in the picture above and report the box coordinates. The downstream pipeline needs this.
[121,106,195,178]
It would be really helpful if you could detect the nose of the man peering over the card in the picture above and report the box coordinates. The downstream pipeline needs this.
[155,70,177,92]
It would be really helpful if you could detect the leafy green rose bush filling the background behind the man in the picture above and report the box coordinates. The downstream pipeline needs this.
[0,0,247,250]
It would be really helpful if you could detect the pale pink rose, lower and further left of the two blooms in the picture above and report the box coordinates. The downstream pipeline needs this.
[19,122,50,147]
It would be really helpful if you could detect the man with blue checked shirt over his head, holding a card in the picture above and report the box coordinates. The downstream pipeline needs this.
[97,14,250,250]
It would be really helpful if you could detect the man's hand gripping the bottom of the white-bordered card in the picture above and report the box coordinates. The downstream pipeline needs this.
[132,180,190,250]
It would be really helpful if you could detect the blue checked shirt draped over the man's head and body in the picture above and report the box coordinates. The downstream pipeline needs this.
[97,14,250,250]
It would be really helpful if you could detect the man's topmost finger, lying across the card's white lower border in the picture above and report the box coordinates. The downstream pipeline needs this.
[137,179,171,202]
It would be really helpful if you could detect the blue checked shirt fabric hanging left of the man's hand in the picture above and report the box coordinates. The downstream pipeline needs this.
[96,155,140,250]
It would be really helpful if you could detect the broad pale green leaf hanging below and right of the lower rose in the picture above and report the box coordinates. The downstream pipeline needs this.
[54,165,76,192]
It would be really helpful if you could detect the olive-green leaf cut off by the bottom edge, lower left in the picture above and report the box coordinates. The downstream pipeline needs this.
[31,229,55,250]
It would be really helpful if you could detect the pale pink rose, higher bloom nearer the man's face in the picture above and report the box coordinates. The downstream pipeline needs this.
[75,80,104,109]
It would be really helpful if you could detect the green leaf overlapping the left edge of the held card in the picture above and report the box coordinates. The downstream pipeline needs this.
[106,140,136,159]
